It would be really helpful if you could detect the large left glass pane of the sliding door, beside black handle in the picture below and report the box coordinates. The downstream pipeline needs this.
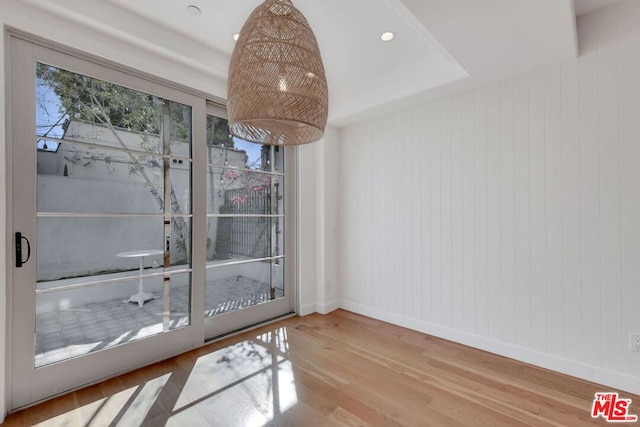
[34,63,191,368]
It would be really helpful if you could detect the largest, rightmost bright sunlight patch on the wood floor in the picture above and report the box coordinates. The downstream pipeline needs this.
[168,330,298,426]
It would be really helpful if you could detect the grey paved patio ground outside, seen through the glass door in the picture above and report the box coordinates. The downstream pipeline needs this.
[35,276,284,367]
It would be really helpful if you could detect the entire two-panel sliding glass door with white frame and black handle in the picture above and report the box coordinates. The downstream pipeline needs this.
[7,36,294,409]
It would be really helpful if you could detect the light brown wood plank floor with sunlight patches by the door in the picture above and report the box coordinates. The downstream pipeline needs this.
[4,310,640,427]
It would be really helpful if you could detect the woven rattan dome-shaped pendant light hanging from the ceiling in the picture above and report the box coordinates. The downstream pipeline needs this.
[227,0,328,145]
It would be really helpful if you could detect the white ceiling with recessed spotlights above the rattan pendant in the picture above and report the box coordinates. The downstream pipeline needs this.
[18,0,619,126]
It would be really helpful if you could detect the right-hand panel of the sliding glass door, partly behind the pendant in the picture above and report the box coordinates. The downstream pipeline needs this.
[205,108,292,338]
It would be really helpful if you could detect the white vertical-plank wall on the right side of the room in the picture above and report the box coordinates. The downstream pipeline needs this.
[339,1,640,393]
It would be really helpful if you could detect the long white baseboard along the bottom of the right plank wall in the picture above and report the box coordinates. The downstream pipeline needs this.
[339,301,640,394]
